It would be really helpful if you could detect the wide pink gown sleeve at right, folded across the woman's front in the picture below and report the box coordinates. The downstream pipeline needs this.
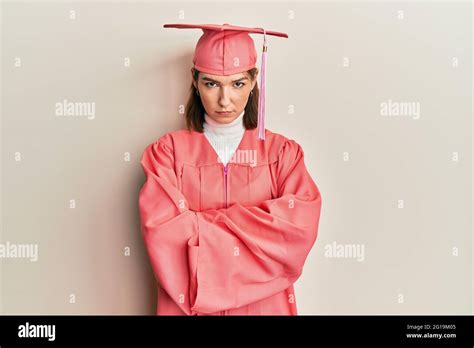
[189,140,322,313]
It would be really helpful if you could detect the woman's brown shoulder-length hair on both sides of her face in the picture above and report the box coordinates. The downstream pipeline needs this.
[185,68,259,133]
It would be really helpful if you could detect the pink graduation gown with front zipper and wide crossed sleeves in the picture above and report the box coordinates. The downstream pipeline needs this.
[139,125,321,315]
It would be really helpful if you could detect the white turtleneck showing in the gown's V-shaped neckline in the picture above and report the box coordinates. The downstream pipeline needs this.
[203,110,245,165]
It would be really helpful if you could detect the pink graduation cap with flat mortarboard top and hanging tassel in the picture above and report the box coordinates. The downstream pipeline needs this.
[163,23,288,139]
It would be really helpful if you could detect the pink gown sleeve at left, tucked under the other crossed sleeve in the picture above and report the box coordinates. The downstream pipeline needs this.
[138,136,198,315]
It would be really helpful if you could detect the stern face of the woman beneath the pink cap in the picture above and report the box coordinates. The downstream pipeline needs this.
[191,69,257,123]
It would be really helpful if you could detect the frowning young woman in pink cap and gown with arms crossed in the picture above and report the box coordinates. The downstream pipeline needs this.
[139,24,321,315]
